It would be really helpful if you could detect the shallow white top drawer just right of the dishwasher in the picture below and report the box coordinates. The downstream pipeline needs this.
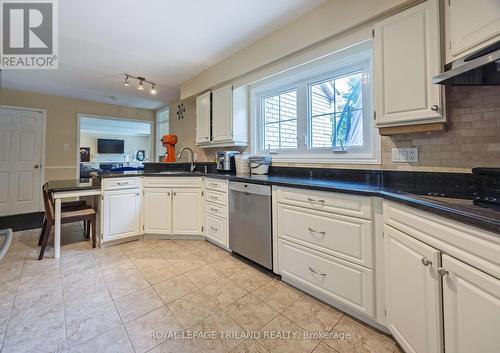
[278,188,372,219]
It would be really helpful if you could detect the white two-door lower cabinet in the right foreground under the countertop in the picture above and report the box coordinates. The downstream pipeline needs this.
[384,202,500,353]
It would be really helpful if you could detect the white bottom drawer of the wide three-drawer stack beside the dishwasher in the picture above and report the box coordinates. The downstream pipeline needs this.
[278,239,373,317]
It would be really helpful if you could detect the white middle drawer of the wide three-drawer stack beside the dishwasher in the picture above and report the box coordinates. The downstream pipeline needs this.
[278,205,373,268]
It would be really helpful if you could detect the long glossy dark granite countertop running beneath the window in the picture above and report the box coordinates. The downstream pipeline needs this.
[94,170,500,236]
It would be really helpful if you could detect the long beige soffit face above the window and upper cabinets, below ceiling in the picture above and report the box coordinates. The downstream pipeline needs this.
[181,0,420,99]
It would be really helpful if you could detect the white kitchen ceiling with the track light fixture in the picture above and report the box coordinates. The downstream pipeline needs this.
[2,0,325,109]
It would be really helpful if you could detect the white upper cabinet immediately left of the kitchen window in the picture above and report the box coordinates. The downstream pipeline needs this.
[196,84,249,147]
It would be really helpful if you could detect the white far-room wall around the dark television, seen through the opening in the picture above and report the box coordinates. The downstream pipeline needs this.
[80,131,151,162]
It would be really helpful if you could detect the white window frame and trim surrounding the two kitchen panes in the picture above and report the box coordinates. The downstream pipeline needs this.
[250,41,381,164]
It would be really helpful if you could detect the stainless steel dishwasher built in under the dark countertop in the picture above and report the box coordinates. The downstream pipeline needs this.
[229,181,273,269]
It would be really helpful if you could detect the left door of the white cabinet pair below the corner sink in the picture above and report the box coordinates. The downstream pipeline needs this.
[144,188,172,234]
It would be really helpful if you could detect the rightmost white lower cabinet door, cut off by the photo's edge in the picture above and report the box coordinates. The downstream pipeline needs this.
[443,255,500,353]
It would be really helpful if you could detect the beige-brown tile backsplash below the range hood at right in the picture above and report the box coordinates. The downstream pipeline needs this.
[382,86,500,171]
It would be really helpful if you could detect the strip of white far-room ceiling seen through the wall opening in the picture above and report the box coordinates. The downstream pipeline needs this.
[80,117,151,136]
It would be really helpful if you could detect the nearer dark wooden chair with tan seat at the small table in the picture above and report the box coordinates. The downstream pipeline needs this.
[38,184,96,260]
